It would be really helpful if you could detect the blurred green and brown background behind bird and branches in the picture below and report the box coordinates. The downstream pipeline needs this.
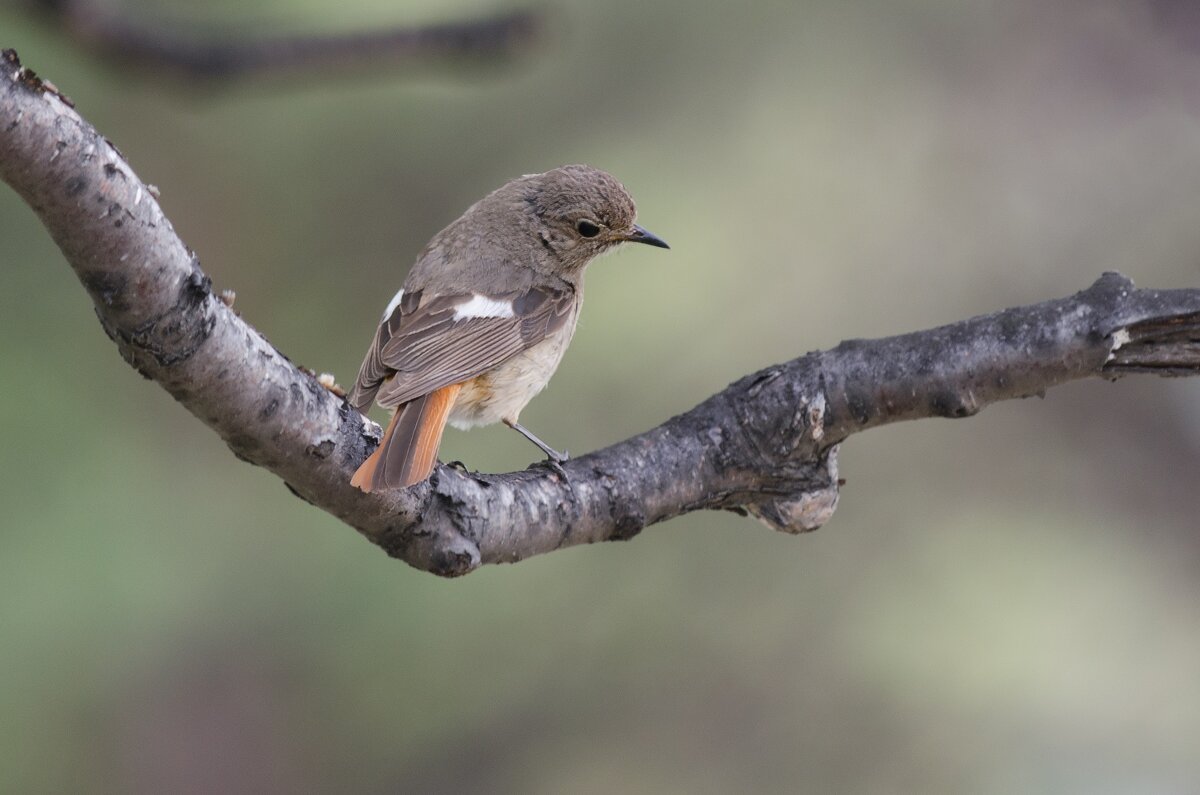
[0,0,1200,793]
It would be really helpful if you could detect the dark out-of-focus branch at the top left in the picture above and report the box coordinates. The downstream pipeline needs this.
[10,0,541,82]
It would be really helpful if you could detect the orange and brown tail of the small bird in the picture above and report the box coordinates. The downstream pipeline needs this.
[350,384,462,492]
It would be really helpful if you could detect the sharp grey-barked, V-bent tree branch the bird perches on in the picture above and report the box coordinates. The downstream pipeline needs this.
[7,50,1200,575]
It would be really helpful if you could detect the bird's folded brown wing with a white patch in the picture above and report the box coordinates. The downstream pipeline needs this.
[349,287,575,411]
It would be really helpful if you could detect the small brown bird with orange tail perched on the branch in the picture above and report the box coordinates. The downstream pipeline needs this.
[348,166,668,491]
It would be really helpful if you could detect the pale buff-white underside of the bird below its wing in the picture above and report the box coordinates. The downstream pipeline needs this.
[449,318,575,429]
